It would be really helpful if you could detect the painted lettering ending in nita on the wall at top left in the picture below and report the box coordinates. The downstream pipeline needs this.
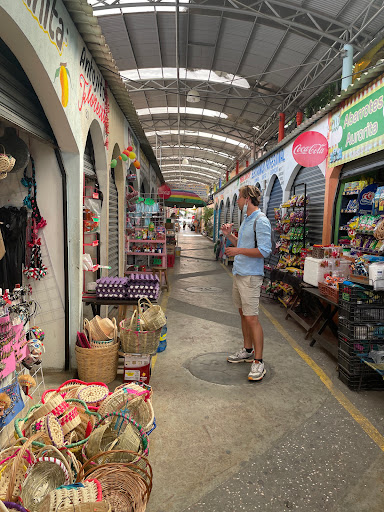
[23,0,68,55]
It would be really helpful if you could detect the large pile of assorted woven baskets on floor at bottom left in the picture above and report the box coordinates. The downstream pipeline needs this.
[0,380,156,512]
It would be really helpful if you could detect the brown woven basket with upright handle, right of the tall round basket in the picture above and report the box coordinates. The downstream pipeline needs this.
[120,310,161,354]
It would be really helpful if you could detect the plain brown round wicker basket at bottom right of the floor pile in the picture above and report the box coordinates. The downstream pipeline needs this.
[77,460,152,512]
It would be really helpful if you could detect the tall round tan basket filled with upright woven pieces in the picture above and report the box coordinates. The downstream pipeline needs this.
[75,316,119,384]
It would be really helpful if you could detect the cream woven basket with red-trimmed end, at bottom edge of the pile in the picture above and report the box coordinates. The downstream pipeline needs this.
[36,479,103,512]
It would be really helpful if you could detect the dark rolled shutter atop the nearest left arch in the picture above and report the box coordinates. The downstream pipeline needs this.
[0,39,55,143]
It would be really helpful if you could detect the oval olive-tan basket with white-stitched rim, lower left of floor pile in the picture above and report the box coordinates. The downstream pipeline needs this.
[20,456,72,511]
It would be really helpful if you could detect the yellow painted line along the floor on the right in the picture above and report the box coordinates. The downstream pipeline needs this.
[223,265,384,452]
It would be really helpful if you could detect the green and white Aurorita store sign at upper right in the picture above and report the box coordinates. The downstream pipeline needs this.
[328,75,384,167]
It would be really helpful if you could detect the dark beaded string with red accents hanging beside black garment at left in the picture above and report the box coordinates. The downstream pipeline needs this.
[21,156,48,280]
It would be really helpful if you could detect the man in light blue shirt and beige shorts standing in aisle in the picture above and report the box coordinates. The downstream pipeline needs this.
[221,185,272,380]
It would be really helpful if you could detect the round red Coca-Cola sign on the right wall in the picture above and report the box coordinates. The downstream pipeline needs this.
[292,132,328,167]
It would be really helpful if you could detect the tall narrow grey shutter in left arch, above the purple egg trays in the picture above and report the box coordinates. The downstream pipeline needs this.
[108,169,119,277]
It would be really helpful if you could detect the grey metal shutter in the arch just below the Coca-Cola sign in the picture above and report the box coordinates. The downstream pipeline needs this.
[291,166,325,245]
